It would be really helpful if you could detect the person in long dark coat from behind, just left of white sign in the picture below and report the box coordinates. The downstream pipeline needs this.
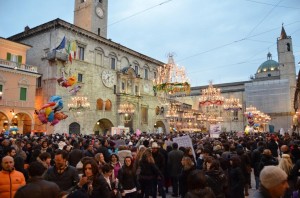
[168,142,183,197]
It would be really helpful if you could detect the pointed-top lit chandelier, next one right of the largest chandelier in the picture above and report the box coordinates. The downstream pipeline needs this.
[199,81,224,106]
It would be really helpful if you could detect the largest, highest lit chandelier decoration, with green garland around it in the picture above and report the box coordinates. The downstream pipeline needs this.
[153,54,191,105]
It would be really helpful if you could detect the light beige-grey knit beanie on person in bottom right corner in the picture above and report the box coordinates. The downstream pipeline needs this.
[259,166,287,189]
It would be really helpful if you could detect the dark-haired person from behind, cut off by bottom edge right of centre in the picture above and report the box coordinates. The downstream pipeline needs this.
[185,170,215,198]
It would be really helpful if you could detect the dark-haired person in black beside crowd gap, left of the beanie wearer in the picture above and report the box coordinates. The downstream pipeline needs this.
[228,156,245,198]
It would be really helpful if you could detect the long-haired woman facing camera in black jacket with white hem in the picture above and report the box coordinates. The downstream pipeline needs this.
[118,156,138,198]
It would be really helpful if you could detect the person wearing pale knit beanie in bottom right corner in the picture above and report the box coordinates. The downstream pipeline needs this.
[253,166,289,198]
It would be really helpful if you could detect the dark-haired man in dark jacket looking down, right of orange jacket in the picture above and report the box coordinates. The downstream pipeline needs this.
[44,150,79,191]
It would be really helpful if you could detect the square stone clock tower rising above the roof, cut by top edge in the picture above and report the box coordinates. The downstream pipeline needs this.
[74,0,108,38]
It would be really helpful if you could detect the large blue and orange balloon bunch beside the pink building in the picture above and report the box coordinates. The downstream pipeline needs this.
[35,96,68,126]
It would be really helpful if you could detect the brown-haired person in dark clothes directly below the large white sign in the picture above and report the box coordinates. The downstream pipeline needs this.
[179,156,195,198]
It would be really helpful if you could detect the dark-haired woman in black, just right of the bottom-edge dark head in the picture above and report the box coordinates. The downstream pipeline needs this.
[204,157,227,198]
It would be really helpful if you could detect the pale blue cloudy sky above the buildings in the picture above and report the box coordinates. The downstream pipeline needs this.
[0,0,300,86]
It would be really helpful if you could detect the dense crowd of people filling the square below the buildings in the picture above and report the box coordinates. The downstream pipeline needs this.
[0,130,300,198]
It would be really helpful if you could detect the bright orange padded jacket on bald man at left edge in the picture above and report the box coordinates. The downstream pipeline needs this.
[0,170,26,198]
